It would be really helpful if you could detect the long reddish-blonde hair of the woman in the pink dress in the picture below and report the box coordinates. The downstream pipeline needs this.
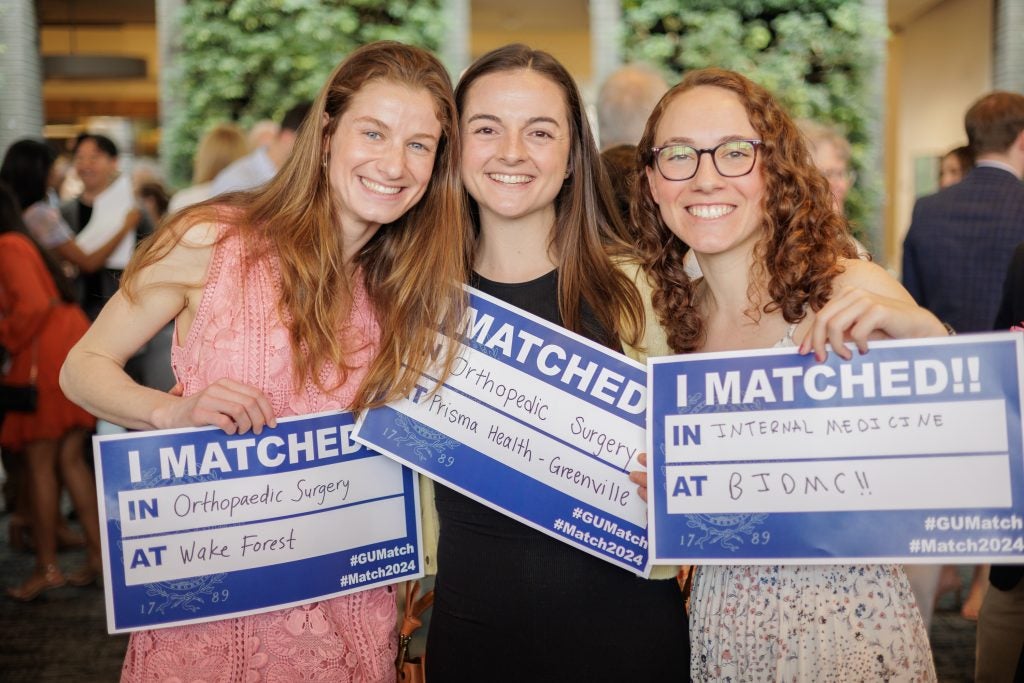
[125,41,470,410]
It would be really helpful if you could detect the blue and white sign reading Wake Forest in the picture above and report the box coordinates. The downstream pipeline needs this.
[94,412,423,633]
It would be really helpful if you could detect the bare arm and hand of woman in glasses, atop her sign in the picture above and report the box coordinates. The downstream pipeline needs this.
[800,259,947,360]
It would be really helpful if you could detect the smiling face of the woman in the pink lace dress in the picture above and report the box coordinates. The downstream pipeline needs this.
[329,81,441,243]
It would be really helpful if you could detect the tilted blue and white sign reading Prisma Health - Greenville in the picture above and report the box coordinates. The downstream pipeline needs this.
[354,290,648,574]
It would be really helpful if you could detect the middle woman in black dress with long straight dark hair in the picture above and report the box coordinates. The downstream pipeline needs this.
[427,45,688,683]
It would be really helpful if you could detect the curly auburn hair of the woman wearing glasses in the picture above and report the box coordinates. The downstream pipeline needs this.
[630,69,857,353]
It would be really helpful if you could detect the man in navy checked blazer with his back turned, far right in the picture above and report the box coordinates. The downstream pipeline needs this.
[903,92,1024,683]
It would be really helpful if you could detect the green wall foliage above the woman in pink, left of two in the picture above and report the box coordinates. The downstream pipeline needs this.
[161,0,444,185]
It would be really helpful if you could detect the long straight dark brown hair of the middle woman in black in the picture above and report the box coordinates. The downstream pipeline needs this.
[455,43,644,348]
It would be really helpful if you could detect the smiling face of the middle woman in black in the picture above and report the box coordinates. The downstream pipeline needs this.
[461,70,569,225]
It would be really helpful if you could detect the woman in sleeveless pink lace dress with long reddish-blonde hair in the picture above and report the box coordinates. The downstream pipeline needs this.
[61,42,468,681]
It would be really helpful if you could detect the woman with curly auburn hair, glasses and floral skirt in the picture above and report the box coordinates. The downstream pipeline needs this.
[633,69,945,681]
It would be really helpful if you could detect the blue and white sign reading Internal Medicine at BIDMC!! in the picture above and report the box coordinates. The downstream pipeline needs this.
[648,333,1024,564]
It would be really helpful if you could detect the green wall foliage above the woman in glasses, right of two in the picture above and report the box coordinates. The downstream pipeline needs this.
[622,0,887,245]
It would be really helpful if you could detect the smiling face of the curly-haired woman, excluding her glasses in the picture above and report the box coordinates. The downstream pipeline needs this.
[645,85,765,254]
